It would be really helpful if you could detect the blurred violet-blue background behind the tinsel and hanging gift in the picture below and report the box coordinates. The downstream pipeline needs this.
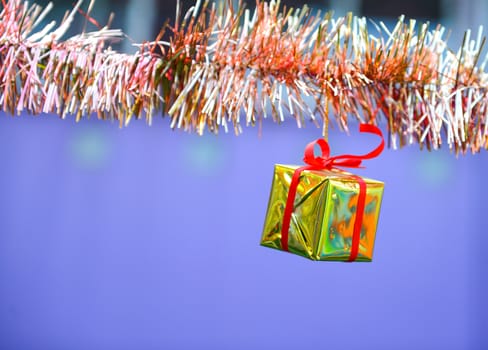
[0,0,488,350]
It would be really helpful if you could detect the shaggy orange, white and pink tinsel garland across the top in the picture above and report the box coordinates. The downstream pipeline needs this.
[0,0,488,153]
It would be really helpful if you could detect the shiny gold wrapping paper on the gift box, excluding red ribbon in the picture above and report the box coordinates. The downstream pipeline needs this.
[261,164,384,261]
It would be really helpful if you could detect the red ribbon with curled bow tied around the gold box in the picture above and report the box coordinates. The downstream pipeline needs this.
[281,124,385,261]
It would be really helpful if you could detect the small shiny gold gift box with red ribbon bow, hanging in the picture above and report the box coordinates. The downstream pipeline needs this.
[261,125,384,261]
